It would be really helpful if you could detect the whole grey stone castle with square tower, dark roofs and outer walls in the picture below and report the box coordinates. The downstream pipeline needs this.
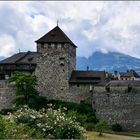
[0,26,140,130]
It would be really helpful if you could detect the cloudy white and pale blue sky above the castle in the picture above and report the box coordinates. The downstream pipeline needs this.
[0,1,140,58]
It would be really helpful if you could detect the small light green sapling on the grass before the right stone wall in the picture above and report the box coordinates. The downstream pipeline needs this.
[95,121,107,136]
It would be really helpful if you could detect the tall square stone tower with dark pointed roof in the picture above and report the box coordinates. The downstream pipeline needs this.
[35,26,76,101]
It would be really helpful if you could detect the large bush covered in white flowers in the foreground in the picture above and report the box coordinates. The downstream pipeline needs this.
[8,106,84,139]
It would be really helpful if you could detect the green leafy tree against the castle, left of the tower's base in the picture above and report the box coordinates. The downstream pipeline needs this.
[9,72,39,106]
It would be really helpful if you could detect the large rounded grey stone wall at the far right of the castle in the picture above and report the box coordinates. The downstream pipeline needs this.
[92,87,140,131]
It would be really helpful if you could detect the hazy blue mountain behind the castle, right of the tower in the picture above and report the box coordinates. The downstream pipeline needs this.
[76,52,140,74]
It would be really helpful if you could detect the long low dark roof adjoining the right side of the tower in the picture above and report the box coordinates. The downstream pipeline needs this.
[69,71,106,84]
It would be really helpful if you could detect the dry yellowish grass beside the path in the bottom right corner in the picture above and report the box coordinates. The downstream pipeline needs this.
[84,131,140,140]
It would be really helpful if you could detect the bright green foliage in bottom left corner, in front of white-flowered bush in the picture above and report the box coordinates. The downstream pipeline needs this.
[0,116,44,139]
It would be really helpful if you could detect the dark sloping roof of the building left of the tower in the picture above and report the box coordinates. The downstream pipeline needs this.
[0,51,37,64]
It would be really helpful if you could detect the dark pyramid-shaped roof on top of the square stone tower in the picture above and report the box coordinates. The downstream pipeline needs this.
[35,26,77,47]
